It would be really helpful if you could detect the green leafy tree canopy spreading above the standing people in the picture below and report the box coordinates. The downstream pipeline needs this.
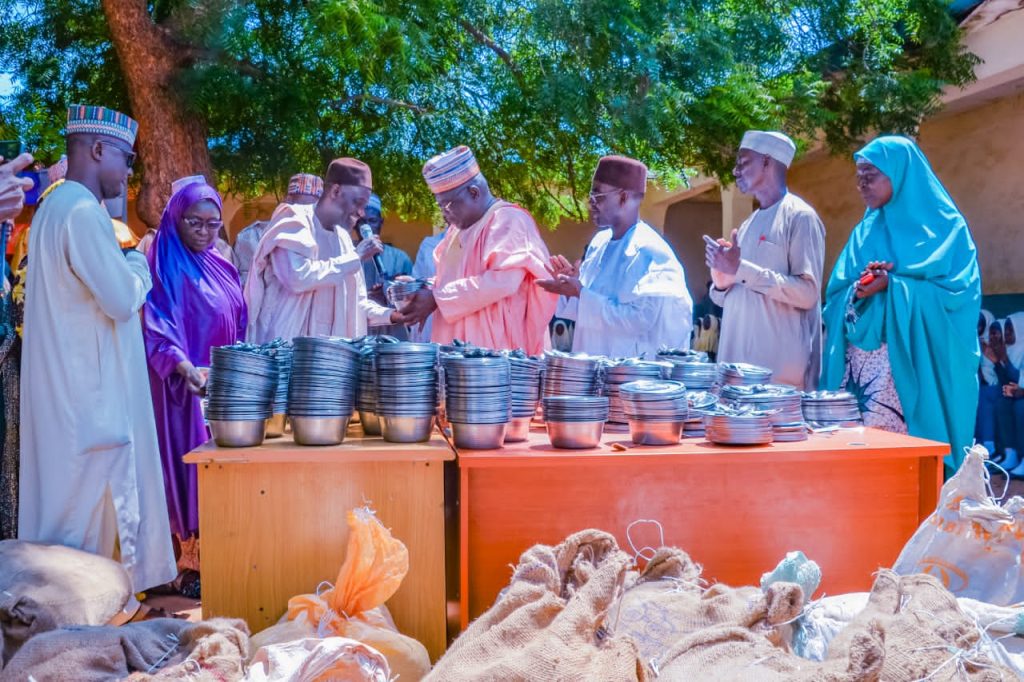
[0,0,976,225]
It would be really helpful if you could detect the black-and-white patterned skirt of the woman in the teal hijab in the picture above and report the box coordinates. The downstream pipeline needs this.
[842,343,907,433]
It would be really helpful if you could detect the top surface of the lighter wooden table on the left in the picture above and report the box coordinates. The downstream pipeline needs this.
[184,424,455,464]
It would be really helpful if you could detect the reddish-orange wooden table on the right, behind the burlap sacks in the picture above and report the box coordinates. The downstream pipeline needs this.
[459,429,949,628]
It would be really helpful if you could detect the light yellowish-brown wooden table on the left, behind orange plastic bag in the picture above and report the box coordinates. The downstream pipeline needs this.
[185,427,455,660]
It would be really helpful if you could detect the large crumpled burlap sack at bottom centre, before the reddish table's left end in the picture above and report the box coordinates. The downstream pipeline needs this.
[426,530,646,682]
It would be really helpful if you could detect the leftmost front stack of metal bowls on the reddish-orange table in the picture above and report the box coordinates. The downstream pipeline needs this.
[443,355,512,450]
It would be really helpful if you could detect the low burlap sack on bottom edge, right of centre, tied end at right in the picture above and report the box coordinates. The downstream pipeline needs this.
[657,627,884,682]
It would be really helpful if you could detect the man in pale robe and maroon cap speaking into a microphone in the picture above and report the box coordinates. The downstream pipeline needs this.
[245,159,400,343]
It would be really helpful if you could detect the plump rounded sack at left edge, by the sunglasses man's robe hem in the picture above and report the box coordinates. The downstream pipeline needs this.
[0,540,131,669]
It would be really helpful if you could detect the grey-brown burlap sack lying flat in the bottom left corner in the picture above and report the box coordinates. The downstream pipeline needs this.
[0,619,248,682]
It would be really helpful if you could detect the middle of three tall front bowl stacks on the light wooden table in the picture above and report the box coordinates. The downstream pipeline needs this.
[288,336,359,445]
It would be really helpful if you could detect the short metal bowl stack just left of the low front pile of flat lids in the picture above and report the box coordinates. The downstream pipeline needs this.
[618,380,689,445]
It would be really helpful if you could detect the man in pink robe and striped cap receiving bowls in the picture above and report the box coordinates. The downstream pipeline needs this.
[401,146,558,355]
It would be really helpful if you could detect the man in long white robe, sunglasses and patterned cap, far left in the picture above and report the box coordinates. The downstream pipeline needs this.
[18,105,177,610]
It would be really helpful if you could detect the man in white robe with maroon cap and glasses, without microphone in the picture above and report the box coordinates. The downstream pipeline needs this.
[538,157,693,358]
